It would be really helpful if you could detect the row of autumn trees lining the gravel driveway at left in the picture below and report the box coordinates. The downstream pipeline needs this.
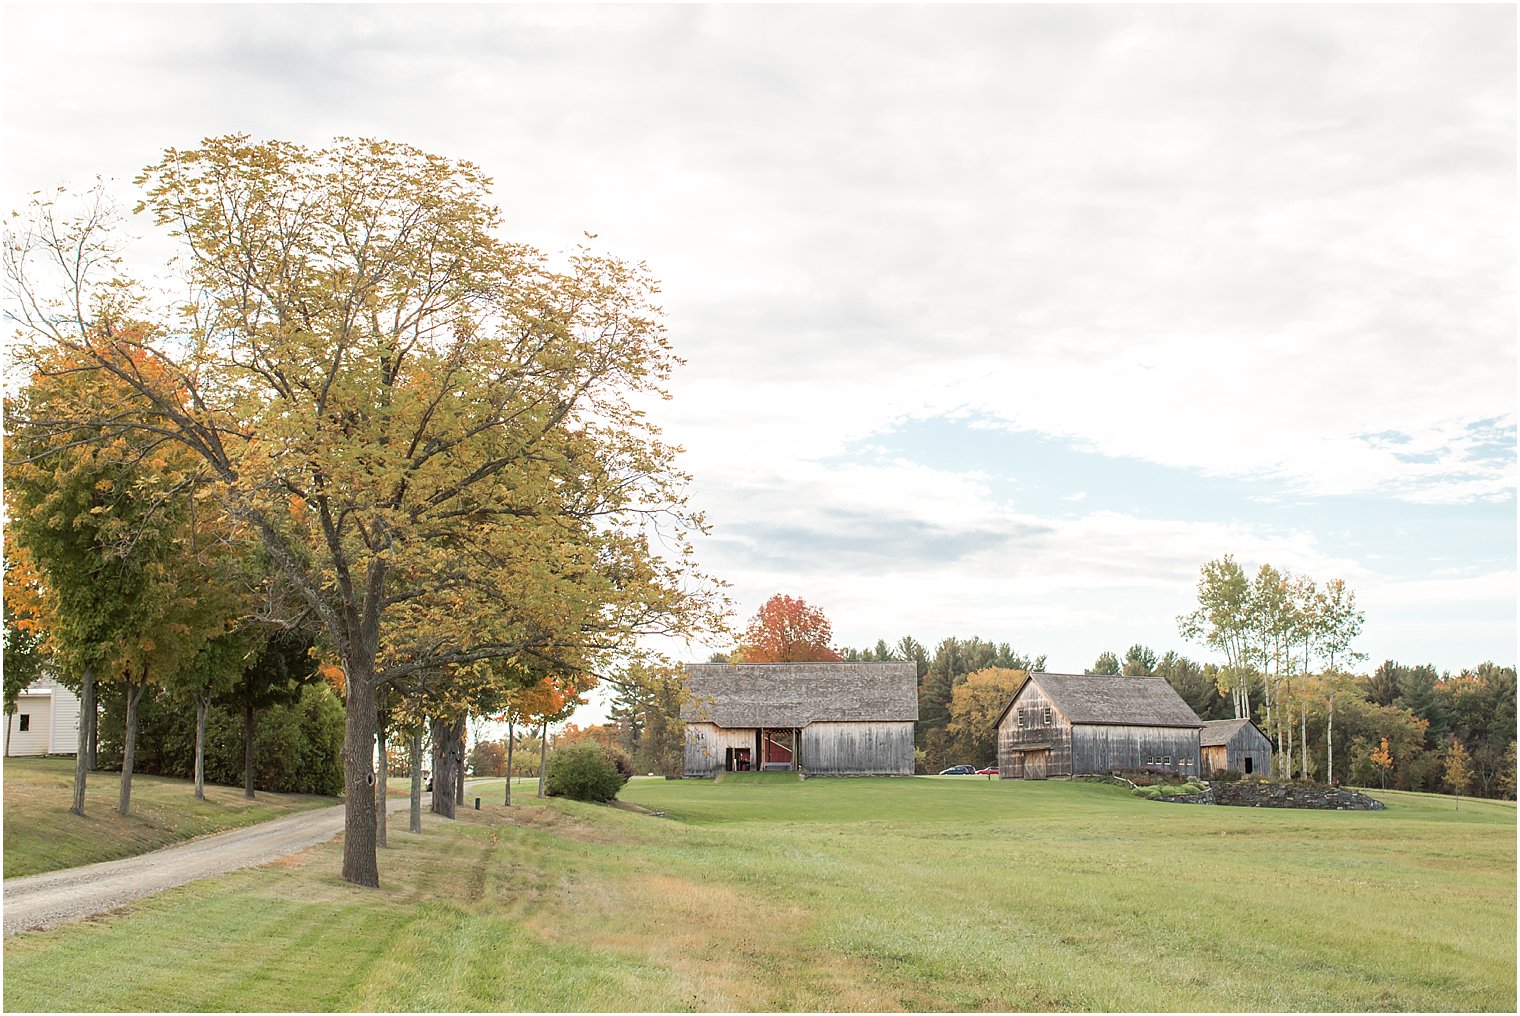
[5,135,727,885]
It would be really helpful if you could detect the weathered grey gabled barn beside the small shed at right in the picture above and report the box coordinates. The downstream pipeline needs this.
[997,674,1204,780]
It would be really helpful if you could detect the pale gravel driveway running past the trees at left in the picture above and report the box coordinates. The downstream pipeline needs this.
[5,794,427,935]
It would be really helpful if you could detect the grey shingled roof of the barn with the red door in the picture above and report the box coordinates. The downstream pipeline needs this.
[681,662,918,727]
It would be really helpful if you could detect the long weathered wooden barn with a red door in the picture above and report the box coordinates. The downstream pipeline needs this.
[681,662,918,776]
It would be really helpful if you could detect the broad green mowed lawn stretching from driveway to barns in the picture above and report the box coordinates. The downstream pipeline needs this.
[5,776,1515,1011]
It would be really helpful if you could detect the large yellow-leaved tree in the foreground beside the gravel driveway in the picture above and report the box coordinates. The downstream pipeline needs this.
[6,135,724,885]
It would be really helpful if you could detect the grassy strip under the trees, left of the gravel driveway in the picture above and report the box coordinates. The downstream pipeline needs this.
[3,759,339,879]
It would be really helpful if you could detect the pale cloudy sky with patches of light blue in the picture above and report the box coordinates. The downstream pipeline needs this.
[0,5,1517,727]
